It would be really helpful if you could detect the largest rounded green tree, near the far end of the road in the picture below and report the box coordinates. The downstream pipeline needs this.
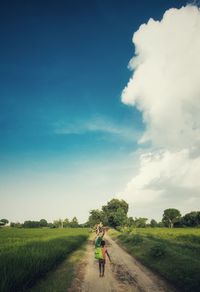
[102,199,128,228]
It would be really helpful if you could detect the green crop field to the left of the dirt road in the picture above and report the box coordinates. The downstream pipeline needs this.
[0,228,89,292]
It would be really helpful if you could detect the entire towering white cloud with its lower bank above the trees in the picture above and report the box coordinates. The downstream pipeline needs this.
[122,6,200,214]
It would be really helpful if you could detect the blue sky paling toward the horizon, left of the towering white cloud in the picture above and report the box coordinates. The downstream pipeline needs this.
[0,0,191,222]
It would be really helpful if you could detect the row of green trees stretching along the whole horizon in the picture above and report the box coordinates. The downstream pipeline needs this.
[0,199,200,228]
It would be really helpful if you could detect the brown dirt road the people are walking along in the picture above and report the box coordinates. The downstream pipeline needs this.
[70,235,174,292]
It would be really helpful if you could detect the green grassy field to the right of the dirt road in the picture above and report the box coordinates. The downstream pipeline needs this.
[111,228,200,292]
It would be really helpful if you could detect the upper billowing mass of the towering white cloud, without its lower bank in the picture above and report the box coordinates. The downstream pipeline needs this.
[122,6,200,149]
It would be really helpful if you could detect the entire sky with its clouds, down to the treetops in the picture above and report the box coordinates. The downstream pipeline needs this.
[0,0,200,222]
